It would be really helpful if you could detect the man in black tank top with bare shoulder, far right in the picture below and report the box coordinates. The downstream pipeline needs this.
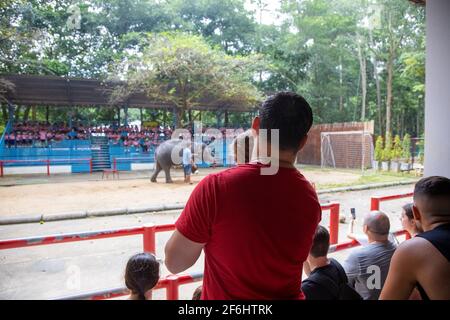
[380,176,450,300]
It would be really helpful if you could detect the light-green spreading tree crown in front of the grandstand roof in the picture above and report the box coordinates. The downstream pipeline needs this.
[113,33,261,127]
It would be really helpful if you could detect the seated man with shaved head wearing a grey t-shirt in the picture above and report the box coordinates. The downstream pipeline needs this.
[342,211,396,300]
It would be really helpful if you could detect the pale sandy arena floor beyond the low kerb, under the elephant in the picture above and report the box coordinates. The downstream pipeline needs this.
[0,168,360,216]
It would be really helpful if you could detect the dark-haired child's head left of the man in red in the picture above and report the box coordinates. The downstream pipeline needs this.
[125,252,159,300]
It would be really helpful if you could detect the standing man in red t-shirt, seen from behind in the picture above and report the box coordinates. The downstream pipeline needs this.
[165,92,321,300]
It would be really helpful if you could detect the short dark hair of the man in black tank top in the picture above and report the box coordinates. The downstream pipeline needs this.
[414,176,450,216]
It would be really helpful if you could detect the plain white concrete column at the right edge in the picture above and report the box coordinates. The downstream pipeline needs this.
[424,0,450,178]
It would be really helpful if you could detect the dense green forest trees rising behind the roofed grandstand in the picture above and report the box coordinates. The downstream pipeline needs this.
[0,0,425,131]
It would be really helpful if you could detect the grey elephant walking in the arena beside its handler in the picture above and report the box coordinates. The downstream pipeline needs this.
[150,139,213,183]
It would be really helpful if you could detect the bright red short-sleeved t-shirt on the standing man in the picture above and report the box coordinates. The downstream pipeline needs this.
[175,164,321,300]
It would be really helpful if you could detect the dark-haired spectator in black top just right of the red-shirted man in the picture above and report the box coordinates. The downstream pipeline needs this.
[302,225,362,300]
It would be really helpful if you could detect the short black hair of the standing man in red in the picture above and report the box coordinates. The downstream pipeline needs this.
[259,92,313,151]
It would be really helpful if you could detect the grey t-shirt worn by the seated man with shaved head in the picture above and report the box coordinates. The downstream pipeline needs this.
[343,241,396,300]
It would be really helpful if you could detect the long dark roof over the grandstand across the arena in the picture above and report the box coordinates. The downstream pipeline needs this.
[0,75,255,112]
